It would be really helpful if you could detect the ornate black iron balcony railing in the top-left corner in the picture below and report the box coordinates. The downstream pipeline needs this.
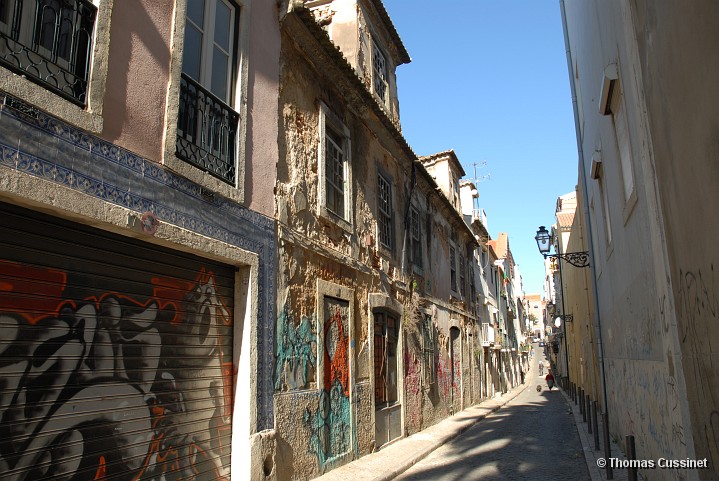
[0,0,97,106]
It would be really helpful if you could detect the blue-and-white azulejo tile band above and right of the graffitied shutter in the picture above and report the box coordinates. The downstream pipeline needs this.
[0,92,276,429]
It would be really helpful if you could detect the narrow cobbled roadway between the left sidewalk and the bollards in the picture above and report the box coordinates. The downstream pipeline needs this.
[397,348,590,481]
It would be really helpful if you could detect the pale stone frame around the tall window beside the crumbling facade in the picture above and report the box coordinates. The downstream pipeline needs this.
[164,0,252,203]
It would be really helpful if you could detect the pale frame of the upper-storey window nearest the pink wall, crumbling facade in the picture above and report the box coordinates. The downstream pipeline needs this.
[317,103,352,232]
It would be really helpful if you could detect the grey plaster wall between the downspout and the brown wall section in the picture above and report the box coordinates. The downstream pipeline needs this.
[564,1,696,480]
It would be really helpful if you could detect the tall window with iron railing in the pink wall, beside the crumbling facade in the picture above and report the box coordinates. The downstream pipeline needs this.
[176,0,239,184]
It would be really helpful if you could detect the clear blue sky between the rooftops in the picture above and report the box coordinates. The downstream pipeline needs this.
[384,0,577,294]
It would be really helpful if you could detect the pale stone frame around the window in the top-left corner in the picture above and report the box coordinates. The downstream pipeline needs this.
[0,0,113,134]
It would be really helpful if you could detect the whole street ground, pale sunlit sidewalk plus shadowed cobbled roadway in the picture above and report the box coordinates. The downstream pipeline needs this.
[317,344,627,481]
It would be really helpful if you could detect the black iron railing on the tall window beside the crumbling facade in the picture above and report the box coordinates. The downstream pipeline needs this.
[175,73,240,185]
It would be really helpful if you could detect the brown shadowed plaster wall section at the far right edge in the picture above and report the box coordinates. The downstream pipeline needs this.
[630,0,719,479]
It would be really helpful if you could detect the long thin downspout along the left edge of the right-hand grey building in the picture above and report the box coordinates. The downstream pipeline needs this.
[559,0,614,472]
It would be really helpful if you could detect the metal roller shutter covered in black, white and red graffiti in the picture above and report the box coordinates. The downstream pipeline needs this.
[0,203,234,481]
